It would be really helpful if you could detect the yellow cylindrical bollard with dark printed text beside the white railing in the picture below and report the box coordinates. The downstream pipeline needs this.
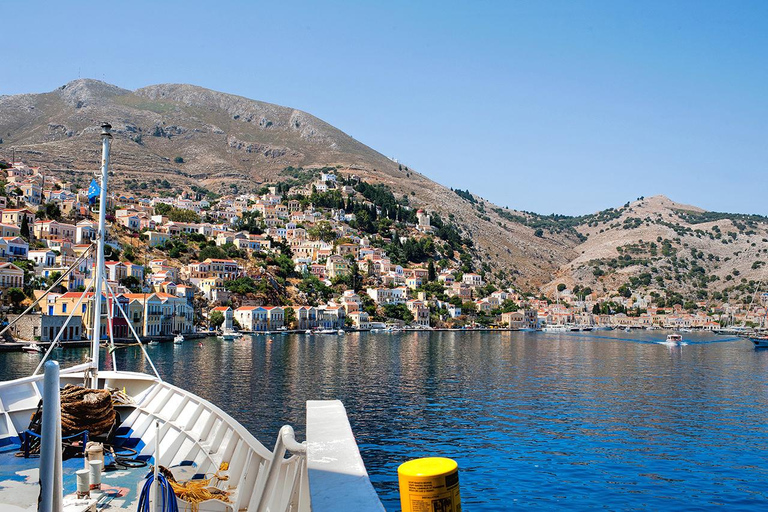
[397,457,461,512]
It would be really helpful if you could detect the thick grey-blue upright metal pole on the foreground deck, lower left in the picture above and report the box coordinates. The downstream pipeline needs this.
[39,361,63,512]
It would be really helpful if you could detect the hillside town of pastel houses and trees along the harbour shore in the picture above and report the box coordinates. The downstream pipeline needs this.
[0,161,768,341]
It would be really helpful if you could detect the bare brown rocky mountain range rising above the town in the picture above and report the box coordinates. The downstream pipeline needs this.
[0,79,768,296]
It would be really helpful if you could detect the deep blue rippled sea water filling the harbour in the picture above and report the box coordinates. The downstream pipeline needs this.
[0,331,768,512]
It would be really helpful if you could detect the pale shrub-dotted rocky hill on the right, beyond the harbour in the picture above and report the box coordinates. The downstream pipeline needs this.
[545,196,768,300]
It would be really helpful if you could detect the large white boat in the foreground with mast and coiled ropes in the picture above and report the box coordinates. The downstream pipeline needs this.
[0,123,384,512]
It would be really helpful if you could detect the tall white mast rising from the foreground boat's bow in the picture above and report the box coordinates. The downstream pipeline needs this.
[91,123,112,389]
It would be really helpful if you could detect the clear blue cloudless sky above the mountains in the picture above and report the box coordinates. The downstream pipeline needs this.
[0,0,768,214]
